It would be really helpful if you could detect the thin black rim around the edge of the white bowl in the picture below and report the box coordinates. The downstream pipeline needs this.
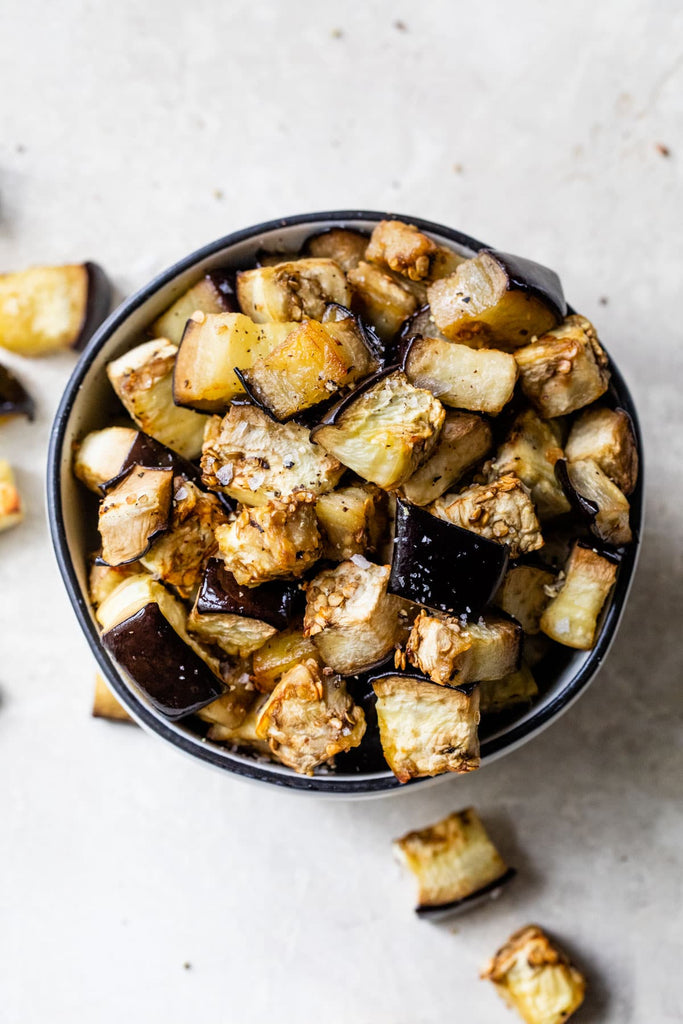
[47,210,643,796]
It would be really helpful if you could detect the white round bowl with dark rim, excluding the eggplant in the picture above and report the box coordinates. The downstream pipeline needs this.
[47,210,642,798]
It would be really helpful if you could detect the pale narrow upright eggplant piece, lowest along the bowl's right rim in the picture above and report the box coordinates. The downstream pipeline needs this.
[541,544,616,650]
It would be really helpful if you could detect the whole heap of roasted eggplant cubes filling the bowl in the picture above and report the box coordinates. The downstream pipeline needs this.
[74,220,638,782]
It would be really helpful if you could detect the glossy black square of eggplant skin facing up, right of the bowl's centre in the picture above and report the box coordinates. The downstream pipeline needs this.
[389,499,508,615]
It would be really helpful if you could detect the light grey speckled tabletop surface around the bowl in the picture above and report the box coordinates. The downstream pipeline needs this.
[0,0,683,1024]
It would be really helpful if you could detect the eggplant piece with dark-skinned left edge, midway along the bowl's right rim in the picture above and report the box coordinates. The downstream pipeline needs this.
[555,459,633,547]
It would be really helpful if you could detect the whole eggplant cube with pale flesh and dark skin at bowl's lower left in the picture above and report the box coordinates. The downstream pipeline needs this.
[97,575,225,719]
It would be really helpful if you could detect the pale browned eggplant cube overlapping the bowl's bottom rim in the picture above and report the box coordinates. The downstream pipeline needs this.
[373,675,479,782]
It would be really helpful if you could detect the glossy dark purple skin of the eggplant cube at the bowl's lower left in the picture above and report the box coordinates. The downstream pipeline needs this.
[102,602,224,720]
